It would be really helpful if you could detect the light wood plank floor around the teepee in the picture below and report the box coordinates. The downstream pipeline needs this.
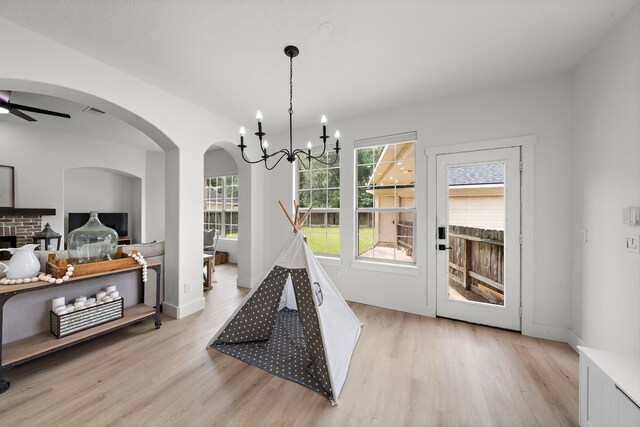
[0,265,578,426]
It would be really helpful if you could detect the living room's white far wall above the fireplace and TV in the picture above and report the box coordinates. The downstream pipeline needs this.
[0,122,145,241]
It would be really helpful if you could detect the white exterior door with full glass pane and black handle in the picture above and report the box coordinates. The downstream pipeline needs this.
[436,147,521,330]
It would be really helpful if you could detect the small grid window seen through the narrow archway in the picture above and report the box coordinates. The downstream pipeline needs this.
[204,175,238,239]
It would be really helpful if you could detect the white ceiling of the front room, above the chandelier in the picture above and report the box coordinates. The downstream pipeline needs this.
[0,0,638,142]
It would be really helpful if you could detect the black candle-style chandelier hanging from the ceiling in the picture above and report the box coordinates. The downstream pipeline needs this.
[238,46,340,170]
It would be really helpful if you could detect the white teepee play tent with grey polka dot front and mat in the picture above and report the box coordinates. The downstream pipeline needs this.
[207,202,362,404]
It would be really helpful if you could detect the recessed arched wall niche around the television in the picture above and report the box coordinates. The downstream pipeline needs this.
[64,168,142,243]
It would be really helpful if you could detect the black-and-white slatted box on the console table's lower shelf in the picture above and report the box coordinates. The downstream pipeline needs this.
[49,298,124,338]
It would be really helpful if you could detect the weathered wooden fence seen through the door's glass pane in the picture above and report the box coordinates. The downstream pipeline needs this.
[449,225,504,304]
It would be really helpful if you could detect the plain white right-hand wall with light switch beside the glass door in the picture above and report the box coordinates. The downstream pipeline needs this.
[570,7,640,356]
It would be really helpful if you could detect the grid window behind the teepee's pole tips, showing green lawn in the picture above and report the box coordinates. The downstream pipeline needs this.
[296,151,340,256]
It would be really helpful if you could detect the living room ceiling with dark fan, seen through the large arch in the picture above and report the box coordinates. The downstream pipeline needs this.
[0,91,162,151]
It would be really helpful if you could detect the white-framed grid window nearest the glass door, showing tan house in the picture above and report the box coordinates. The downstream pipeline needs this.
[355,133,415,263]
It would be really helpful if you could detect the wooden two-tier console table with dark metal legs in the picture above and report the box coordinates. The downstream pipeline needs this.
[0,262,162,394]
